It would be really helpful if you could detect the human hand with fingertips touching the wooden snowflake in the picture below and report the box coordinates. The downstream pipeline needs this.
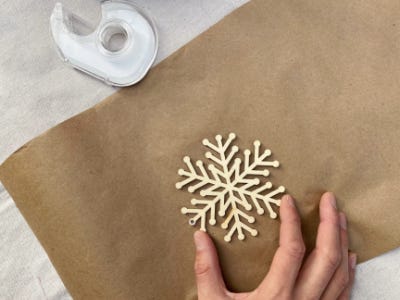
[194,193,357,300]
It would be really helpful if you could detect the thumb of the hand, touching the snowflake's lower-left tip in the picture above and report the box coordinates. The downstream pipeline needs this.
[194,231,227,300]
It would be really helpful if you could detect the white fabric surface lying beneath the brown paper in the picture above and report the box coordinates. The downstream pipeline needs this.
[0,0,400,300]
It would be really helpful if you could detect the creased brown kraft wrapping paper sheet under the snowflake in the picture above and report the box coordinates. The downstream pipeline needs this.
[0,1,400,299]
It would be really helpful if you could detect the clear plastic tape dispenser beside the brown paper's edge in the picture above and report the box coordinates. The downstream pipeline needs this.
[50,0,158,86]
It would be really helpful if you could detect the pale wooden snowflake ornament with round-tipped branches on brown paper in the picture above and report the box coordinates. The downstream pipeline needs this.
[176,133,285,242]
